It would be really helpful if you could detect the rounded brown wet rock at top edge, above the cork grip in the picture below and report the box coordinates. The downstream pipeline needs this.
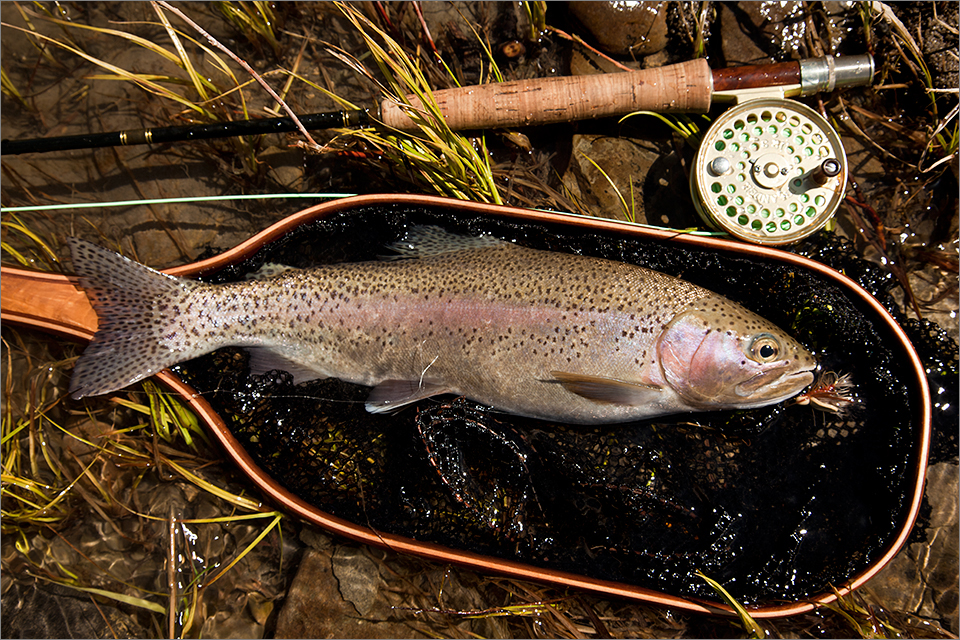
[568,2,667,56]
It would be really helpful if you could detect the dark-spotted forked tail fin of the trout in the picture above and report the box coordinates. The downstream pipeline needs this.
[67,238,198,399]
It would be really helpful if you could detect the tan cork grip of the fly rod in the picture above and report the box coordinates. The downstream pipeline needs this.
[381,59,713,130]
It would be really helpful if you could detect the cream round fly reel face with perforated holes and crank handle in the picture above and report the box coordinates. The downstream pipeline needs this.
[690,98,847,245]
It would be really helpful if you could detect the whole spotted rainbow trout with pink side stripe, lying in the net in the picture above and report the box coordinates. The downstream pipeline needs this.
[70,227,817,424]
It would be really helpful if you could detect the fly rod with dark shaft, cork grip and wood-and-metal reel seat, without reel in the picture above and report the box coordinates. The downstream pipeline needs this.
[0,54,874,155]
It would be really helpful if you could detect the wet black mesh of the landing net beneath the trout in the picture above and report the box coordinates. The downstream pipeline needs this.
[171,205,944,604]
